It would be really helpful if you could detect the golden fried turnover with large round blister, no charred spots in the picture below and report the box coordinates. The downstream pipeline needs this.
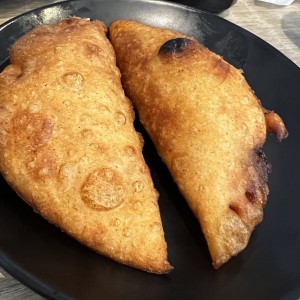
[0,17,172,274]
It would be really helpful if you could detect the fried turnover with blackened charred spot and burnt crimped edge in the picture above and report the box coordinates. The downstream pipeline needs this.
[109,20,287,268]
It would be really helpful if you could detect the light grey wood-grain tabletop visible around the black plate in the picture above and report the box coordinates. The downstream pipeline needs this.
[0,0,300,300]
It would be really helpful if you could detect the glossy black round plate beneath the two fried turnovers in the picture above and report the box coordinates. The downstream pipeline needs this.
[0,0,300,300]
